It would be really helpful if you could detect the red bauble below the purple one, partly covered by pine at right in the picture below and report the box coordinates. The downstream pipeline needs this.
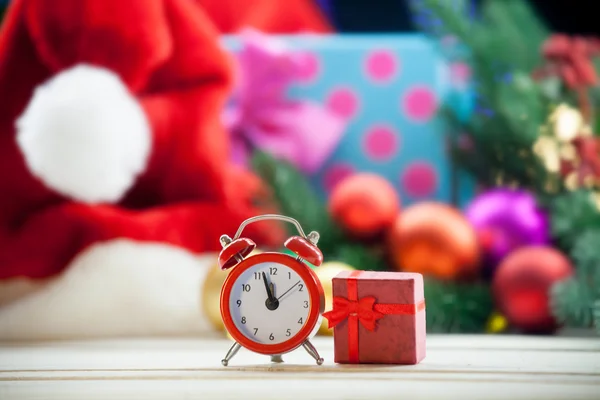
[492,246,573,333]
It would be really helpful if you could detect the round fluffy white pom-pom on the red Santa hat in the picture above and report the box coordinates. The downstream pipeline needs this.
[16,65,151,203]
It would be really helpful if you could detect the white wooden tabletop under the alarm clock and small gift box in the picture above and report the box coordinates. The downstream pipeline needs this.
[0,335,600,400]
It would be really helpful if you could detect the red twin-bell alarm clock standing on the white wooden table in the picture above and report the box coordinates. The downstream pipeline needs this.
[219,214,325,366]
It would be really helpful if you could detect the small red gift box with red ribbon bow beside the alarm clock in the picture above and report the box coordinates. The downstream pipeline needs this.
[323,271,426,364]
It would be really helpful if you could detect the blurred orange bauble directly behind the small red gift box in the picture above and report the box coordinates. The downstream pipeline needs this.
[389,202,479,279]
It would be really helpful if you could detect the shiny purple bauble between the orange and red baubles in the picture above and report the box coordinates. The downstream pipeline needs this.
[465,188,550,276]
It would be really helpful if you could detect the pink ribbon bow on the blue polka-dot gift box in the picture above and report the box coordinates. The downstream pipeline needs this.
[225,30,345,174]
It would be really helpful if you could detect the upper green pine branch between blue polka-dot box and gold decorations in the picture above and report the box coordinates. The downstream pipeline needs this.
[423,0,560,193]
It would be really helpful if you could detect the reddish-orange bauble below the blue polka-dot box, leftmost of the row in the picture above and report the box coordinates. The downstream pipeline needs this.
[329,173,400,237]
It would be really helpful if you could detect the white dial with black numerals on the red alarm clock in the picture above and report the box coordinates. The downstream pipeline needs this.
[229,262,313,344]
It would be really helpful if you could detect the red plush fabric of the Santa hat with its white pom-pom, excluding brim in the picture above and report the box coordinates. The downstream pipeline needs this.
[0,0,292,278]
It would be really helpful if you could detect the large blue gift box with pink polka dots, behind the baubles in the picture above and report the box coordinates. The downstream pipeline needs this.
[224,34,475,207]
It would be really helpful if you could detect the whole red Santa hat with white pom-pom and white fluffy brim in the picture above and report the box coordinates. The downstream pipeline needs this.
[0,0,328,339]
